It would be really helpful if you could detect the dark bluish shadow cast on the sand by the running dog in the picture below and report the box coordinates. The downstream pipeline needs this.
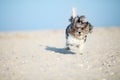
[45,46,75,54]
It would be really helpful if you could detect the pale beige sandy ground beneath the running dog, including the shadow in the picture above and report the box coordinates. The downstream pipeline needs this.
[0,27,120,80]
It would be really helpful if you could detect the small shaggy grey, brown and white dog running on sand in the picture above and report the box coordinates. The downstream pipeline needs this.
[65,9,93,53]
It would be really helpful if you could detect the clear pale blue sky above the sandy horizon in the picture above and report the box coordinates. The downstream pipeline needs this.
[0,0,120,31]
